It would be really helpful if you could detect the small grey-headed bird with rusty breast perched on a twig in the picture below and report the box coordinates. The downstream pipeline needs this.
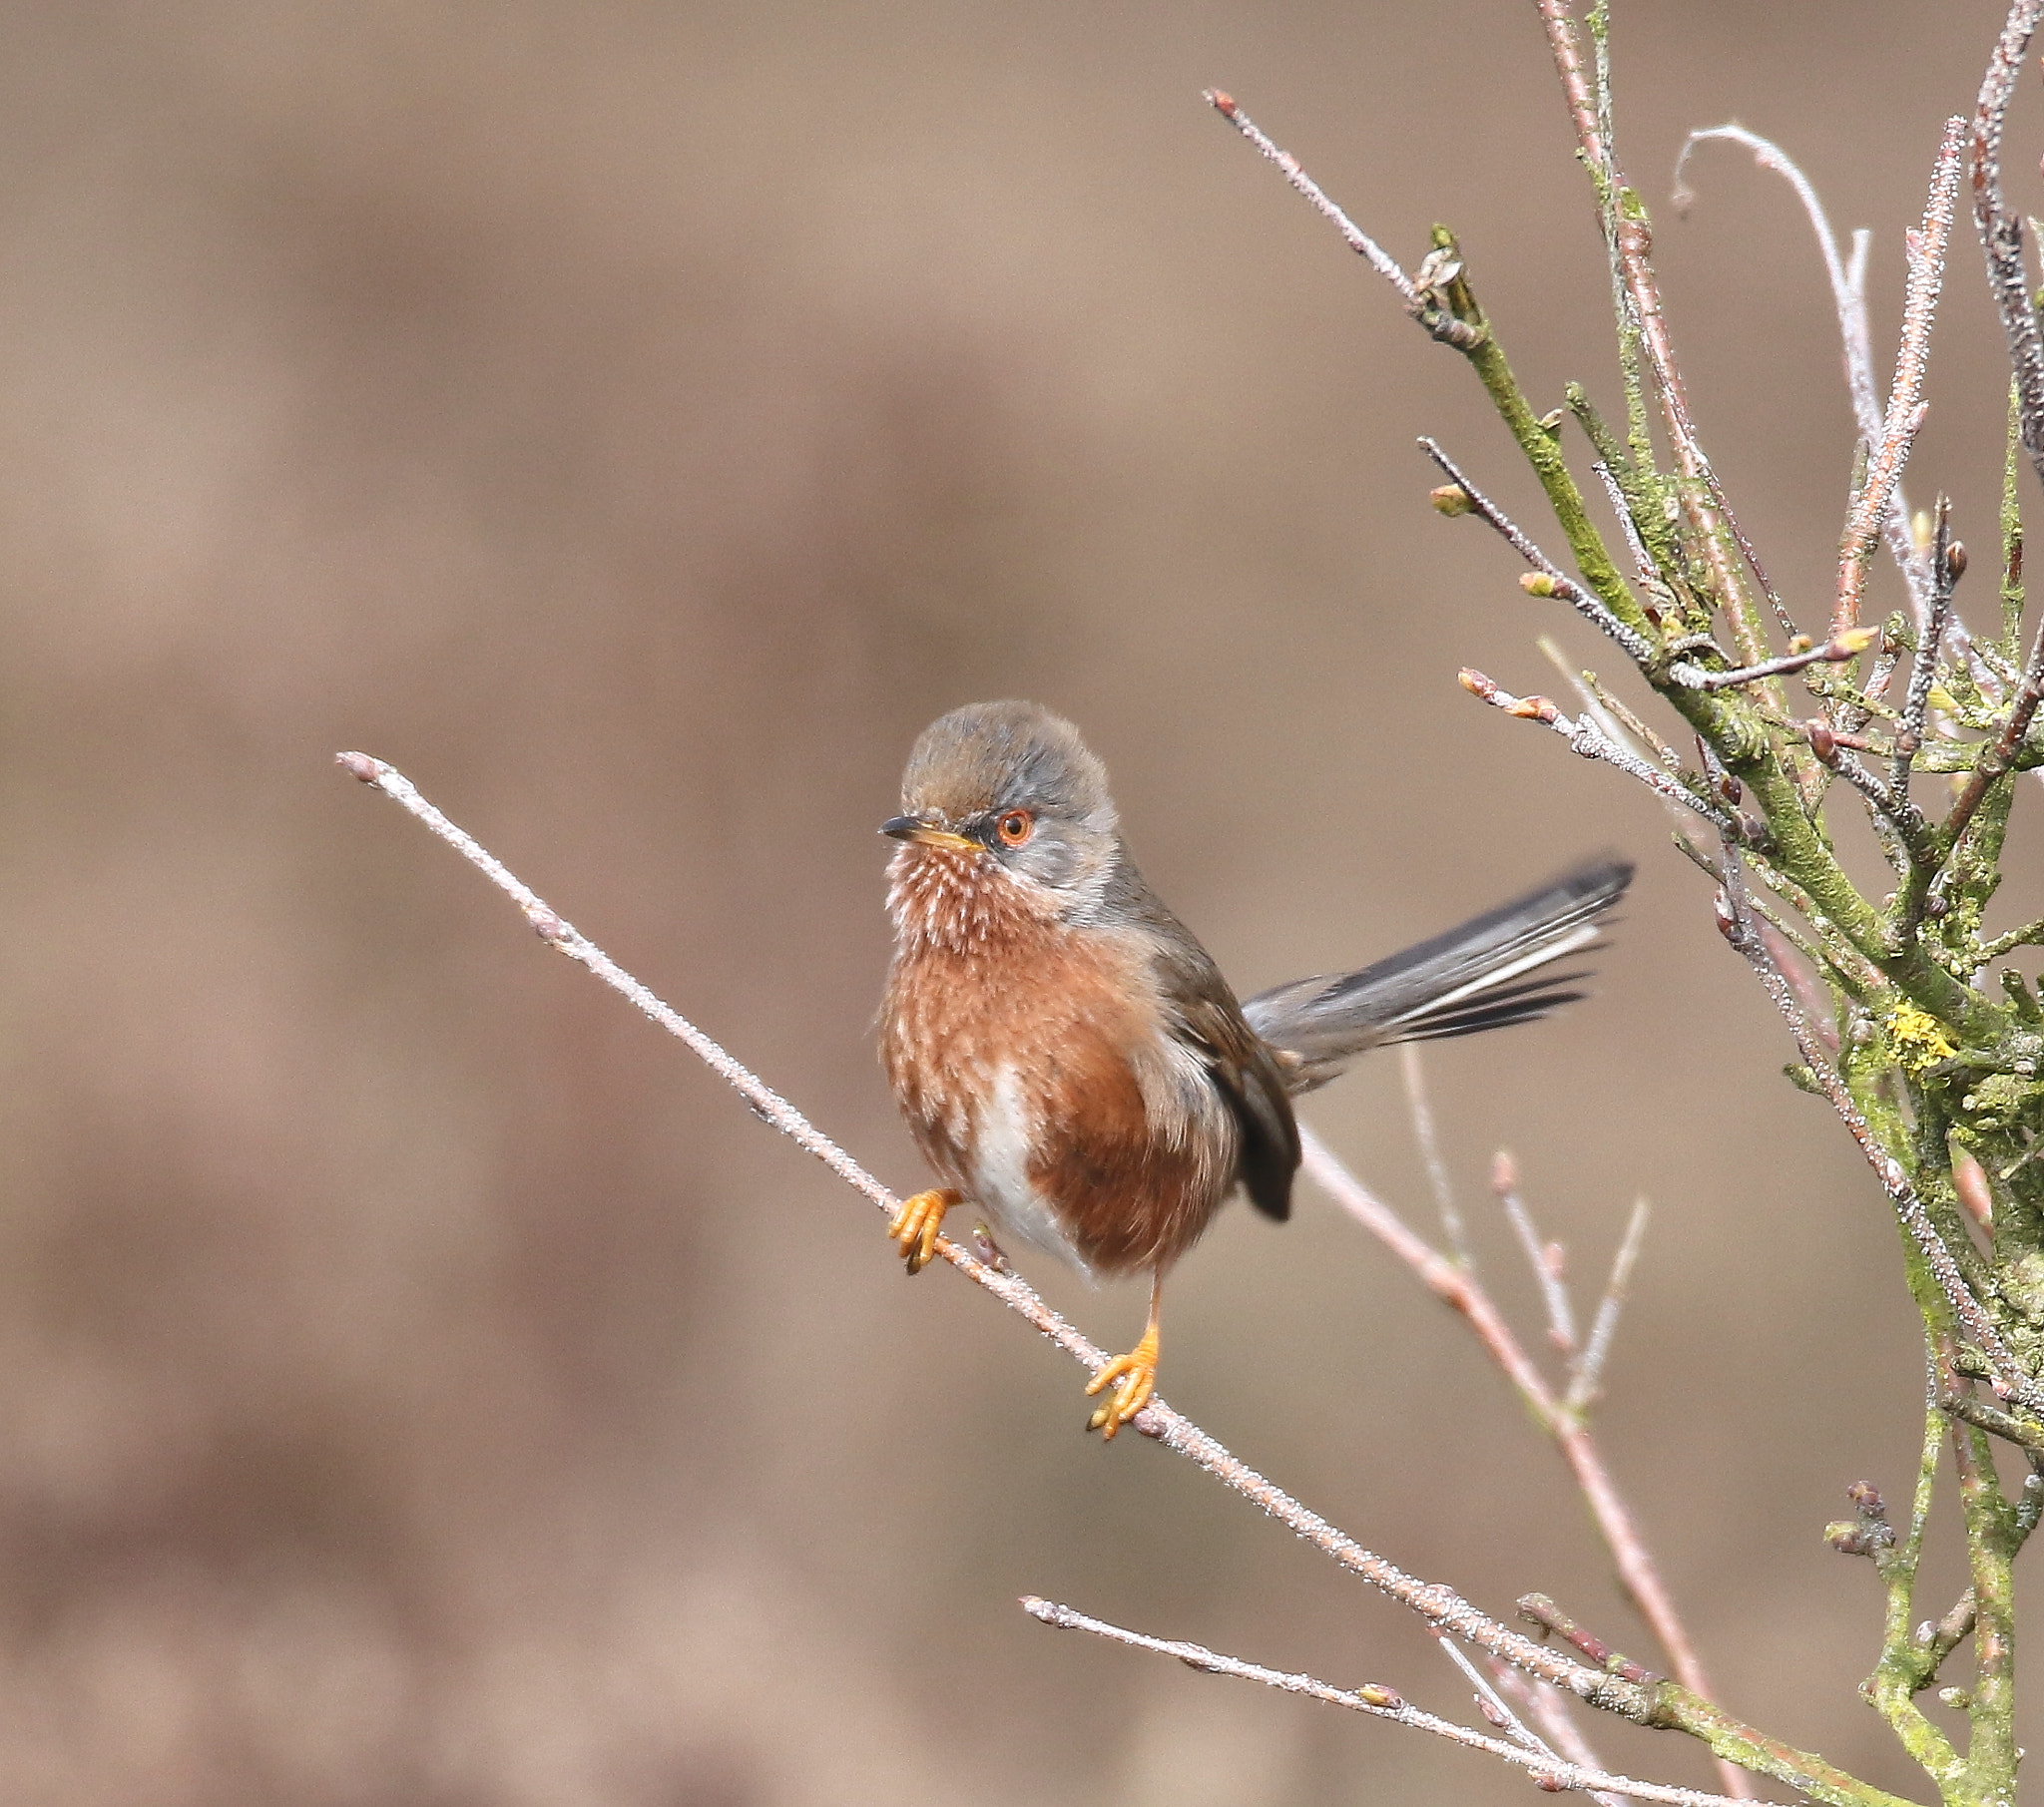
[879,701,1633,1441]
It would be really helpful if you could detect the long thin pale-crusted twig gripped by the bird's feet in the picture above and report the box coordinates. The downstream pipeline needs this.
[337,752,1654,1721]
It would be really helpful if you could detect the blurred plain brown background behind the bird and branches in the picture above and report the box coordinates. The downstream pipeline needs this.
[0,0,2044,1807]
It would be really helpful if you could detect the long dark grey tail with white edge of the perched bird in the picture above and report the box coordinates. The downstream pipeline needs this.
[1243,858,1633,1094]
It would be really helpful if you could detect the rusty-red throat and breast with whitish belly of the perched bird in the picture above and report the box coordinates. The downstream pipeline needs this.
[881,848,1237,1277]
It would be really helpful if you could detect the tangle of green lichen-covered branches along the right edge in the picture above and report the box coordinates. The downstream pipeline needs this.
[1217,0,2044,1803]
